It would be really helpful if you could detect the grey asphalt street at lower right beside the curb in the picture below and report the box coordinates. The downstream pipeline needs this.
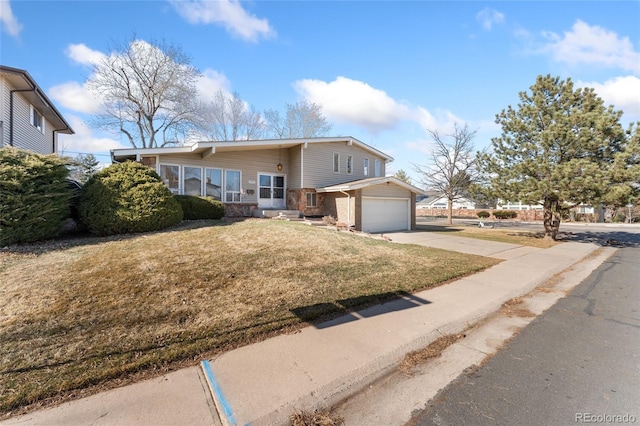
[412,246,640,425]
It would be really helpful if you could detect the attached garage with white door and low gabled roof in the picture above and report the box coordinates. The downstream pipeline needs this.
[316,177,422,233]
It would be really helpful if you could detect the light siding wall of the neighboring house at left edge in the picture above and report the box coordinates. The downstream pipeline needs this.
[2,79,55,154]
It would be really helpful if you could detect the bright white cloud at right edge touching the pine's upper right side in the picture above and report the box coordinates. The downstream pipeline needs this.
[576,75,640,120]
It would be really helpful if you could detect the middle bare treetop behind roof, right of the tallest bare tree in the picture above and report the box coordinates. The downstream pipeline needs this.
[201,90,265,141]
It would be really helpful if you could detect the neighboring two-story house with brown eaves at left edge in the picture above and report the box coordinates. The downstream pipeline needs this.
[0,65,74,154]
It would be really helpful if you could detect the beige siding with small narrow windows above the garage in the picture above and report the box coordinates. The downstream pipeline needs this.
[302,142,385,188]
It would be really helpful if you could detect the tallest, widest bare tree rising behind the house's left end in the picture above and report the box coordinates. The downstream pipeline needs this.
[88,36,199,148]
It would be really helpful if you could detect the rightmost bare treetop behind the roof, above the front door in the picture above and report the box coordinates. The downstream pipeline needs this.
[264,98,333,139]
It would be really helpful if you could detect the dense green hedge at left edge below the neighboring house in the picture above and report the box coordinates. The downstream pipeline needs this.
[0,147,73,246]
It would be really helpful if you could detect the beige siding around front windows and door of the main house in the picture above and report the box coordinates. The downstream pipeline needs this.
[156,150,289,203]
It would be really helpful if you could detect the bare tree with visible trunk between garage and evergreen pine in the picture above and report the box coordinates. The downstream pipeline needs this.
[414,123,479,224]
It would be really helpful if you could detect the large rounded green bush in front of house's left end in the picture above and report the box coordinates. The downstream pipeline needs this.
[79,161,183,235]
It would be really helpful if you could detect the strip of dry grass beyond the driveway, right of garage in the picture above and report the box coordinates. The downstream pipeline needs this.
[416,225,560,248]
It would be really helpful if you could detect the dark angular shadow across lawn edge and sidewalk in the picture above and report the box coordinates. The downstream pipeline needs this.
[291,291,431,329]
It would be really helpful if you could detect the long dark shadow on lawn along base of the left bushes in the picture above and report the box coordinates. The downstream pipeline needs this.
[0,219,233,255]
